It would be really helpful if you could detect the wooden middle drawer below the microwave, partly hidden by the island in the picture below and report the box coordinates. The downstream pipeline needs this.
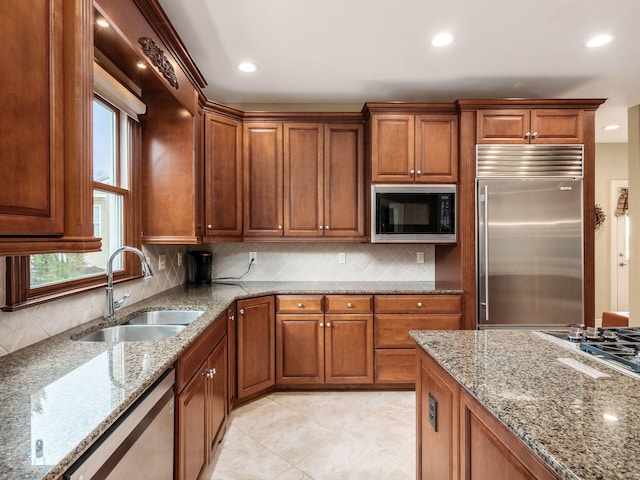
[374,314,462,348]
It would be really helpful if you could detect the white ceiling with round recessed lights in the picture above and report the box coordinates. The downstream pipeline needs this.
[159,0,640,142]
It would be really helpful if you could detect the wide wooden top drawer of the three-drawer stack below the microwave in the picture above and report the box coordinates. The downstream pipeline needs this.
[374,295,462,313]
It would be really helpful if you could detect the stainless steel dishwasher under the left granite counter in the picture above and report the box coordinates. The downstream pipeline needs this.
[63,370,175,480]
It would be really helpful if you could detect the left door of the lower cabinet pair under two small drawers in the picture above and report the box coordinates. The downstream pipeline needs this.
[276,314,324,385]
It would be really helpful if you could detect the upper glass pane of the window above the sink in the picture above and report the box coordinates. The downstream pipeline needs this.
[93,99,118,185]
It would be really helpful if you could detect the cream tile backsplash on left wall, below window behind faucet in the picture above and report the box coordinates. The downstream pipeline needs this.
[0,245,186,356]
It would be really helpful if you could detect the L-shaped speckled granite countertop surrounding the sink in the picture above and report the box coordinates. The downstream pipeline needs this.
[0,282,462,480]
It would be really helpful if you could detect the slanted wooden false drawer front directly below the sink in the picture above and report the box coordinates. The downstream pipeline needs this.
[176,310,227,394]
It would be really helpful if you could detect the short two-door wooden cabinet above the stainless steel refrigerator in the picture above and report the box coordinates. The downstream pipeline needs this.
[477,109,584,144]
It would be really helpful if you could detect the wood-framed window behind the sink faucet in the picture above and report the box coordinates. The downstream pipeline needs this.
[7,63,144,310]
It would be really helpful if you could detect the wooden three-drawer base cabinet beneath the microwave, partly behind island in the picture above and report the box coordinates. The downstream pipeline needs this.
[374,295,462,385]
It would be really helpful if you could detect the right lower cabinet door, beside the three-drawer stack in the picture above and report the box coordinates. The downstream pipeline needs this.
[324,315,373,384]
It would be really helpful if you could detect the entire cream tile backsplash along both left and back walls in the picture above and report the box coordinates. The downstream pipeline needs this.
[0,243,435,356]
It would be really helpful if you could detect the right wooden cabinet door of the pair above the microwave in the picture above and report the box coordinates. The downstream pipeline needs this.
[415,115,458,183]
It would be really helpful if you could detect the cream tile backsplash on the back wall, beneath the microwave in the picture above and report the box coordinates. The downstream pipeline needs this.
[205,242,435,282]
